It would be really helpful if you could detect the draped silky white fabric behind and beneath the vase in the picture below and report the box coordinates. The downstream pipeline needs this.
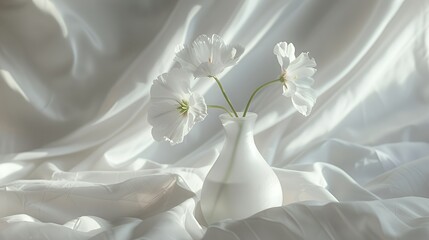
[0,0,429,240]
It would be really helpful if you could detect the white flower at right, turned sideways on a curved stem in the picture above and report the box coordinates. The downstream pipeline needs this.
[274,42,316,116]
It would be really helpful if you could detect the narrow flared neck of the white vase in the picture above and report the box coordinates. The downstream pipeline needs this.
[219,113,258,144]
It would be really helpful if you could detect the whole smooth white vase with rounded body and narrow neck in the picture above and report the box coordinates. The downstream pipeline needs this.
[200,113,283,224]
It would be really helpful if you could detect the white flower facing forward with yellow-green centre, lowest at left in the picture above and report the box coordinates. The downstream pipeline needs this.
[148,68,207,145]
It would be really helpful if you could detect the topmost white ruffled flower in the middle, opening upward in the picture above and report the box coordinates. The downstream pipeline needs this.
[175,34,244,77]
